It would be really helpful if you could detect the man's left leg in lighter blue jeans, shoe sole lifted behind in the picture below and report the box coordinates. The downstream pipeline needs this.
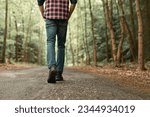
[46,20,57,83]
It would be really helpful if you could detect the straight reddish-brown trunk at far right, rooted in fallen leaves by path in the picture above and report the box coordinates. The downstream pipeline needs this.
[135,0,145,70]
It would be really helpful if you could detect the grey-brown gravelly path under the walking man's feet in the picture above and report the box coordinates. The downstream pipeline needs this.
[0,67,150,100]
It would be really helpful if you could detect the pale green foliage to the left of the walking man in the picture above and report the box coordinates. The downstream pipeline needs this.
[0,0,45,64]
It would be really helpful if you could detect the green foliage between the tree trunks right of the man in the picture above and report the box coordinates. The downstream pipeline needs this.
[66,0,137,64]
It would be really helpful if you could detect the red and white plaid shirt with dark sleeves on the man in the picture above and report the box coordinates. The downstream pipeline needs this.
[37,0,77,19]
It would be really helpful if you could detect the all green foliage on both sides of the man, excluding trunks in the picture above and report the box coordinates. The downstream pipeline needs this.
[0,0,148,65]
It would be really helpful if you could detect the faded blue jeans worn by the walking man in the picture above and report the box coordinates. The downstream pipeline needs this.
[46,19,68,73]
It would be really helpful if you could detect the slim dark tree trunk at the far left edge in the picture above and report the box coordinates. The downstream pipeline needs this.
[2,0,8,63]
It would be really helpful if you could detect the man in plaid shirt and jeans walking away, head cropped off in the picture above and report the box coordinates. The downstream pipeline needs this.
[37,0,77,83]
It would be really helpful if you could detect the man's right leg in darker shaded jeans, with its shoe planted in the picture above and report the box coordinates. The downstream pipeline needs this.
[56,20,68,81]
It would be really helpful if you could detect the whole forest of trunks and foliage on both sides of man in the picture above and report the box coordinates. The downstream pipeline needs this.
[0,0,150,70]
